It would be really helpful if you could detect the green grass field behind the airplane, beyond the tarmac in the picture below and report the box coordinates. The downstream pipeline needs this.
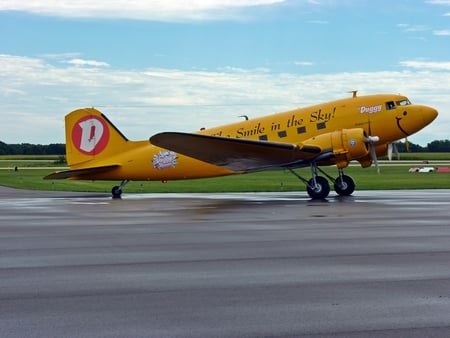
[0,153,450,193]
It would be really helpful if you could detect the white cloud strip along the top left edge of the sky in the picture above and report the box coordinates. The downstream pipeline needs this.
[0,0,285,21]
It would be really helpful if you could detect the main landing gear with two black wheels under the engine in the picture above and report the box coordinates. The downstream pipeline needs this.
[288,163,355,199]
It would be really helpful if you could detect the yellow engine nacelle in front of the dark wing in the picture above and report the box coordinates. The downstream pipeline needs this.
[303,128,370,168]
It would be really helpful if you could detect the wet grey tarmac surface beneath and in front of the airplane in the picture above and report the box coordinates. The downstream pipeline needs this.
[0,187,450,338]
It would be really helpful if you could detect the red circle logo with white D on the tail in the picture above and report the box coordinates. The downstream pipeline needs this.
[72,115,109,155]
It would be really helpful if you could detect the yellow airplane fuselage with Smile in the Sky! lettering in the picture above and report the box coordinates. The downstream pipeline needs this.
[79,94,433,181]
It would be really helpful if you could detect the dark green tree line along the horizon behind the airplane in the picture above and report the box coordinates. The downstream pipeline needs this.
[0,140,450,155]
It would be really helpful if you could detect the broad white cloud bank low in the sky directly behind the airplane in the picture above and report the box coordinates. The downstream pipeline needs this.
[0,55,450,145]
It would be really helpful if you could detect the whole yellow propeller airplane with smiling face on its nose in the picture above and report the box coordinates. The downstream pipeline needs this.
[45,91,438,199]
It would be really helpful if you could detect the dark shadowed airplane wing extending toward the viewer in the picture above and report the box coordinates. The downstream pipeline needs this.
[150,132,321,171]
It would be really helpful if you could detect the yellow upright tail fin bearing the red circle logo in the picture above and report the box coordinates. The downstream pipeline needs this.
[65,108,128,166]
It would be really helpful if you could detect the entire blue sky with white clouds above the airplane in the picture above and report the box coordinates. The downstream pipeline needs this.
[0,0,450,145]
